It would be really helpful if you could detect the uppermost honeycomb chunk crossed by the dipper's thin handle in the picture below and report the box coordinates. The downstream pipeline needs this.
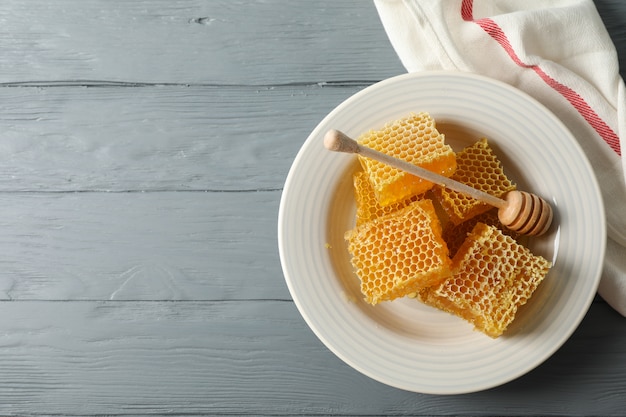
[357,113,456,206]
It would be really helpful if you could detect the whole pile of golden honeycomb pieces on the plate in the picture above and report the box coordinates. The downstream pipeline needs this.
[338,113,551,338]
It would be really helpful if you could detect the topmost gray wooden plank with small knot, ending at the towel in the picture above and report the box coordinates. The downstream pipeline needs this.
[0,0,404,85]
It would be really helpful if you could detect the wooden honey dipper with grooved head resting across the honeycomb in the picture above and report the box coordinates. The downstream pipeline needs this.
[324,129,553,236]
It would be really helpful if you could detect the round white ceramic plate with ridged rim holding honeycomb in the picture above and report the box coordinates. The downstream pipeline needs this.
[278,72,606,394]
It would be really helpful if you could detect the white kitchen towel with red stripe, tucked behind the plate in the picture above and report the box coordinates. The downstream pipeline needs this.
[374,0,626,316]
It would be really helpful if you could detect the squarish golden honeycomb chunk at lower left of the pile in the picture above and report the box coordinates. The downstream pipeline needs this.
[346,200,451,304]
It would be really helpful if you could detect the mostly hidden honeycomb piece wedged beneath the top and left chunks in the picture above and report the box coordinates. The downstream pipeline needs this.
[354,171,420,226]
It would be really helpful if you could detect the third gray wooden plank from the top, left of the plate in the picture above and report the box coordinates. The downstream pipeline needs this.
[0,191,290,300]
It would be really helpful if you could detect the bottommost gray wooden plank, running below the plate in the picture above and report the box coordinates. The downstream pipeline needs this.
[0,301,626,416]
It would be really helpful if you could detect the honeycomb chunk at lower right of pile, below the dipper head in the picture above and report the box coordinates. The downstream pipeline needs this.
[418,223,551,338]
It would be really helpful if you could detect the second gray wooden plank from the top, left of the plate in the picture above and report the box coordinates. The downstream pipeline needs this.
[0,84,364,191]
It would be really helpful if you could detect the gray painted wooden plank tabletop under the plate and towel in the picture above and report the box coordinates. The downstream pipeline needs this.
[0,0,626,416]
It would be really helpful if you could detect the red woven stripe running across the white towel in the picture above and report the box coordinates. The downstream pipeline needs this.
[461,0,622,156]
